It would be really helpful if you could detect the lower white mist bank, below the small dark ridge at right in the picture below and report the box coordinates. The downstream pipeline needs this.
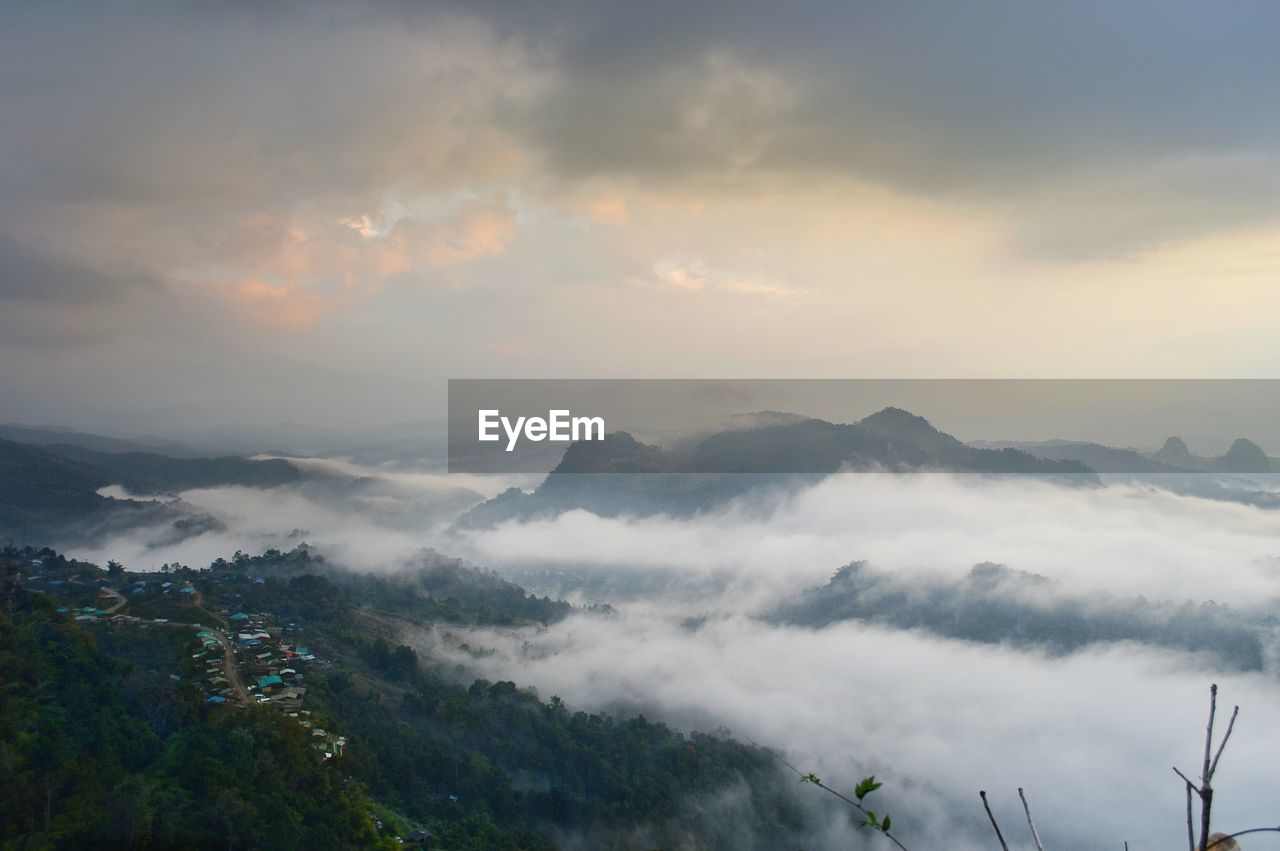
[438,605,1280,850]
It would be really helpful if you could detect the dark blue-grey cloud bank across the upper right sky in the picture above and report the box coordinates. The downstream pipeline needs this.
[471,3,1280,258]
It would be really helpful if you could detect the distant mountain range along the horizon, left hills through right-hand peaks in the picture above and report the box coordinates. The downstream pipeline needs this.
[0,407,1280,541]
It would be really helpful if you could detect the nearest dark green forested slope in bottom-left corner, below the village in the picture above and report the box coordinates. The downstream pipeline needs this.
[0,567,392,850]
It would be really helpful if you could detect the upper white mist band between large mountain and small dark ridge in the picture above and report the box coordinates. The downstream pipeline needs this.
[454,473,1280,609]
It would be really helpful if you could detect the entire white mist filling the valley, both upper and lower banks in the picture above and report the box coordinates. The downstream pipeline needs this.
[57,462,1280,850]
